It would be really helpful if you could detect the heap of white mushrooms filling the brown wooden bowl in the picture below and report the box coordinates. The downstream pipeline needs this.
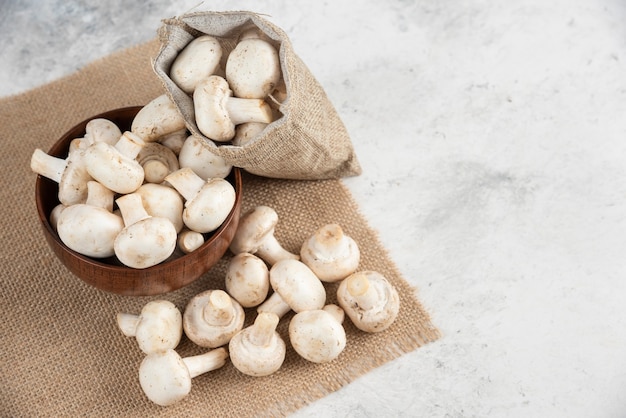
[30,95,235,269]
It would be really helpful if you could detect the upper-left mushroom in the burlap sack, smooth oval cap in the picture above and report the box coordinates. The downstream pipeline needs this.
[170,35,222,94]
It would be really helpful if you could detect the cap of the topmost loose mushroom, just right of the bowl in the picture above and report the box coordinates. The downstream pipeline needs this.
[230,206,278,254]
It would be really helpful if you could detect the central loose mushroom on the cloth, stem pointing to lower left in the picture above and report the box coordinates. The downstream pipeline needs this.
[257,259,326,318]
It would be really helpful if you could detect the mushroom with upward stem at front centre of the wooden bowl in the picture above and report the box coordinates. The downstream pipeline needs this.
[113,193,177,268]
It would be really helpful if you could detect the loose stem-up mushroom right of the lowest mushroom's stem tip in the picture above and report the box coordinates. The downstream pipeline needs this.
[228,312,286,377]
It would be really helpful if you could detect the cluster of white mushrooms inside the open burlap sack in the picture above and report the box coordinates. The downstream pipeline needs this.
[169,27,286,146]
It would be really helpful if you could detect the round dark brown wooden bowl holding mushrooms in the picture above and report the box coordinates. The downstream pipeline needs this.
[35,106,242,296]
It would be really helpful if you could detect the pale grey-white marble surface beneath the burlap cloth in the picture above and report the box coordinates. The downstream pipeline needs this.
[0,0,626,417]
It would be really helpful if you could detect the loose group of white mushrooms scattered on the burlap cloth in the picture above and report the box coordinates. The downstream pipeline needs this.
[117,206,400,405]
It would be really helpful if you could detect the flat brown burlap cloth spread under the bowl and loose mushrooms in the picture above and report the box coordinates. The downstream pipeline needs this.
[0,41,438,417]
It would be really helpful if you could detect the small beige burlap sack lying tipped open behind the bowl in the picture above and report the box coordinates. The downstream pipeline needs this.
[153,12,361,180]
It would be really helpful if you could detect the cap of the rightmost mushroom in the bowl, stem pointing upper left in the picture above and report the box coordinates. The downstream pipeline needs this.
[183,178,236,233]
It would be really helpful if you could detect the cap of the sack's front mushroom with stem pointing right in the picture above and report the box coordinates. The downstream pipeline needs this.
[193,75,235,142]
